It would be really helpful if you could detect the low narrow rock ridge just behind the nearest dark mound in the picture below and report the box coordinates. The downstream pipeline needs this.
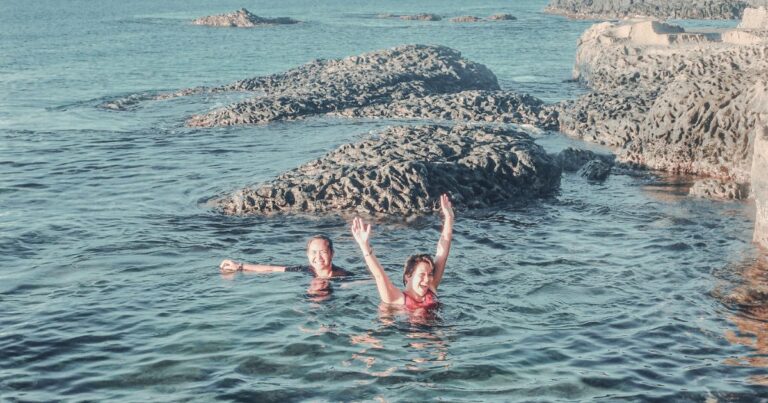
[337,91,558,130]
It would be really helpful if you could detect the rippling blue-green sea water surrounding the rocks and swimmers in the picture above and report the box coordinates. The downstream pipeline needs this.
[0,0,768,402]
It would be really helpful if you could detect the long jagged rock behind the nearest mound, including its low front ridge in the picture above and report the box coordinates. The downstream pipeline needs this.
[101,45,557,129]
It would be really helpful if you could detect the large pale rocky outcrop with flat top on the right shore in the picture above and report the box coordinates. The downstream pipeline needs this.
[557,13,768,185]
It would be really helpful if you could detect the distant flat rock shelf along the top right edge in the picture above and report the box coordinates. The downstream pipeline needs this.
[545,0,768,19]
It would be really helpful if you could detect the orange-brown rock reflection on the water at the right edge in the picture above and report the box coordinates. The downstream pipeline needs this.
[725,254,768,386]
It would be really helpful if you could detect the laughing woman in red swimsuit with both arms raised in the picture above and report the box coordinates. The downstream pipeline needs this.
[352,195,453,309]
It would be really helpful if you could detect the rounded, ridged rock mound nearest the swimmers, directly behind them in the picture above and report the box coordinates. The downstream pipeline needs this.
[215,125,560,216]
